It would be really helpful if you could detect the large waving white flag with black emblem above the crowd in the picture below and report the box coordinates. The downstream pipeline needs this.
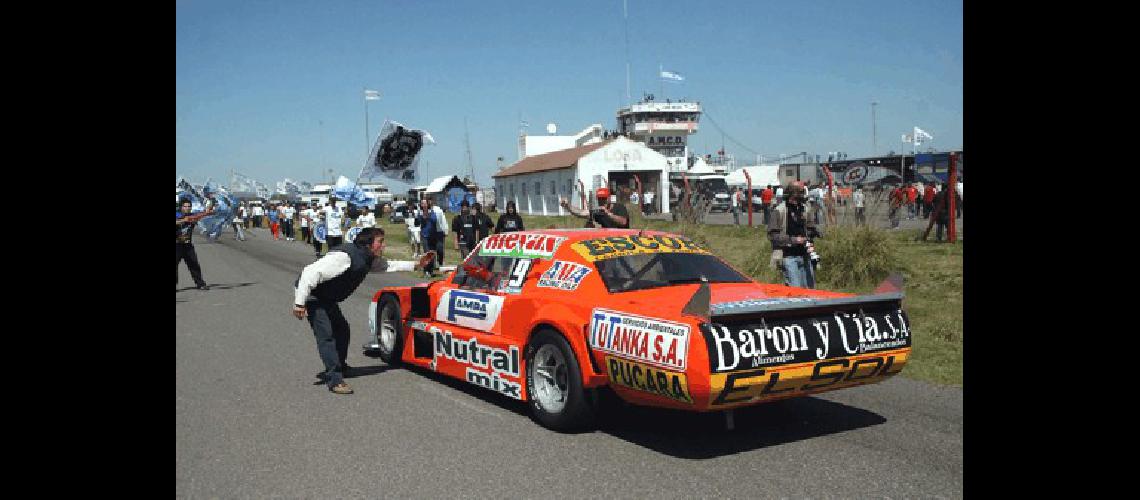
[360,120,435,183]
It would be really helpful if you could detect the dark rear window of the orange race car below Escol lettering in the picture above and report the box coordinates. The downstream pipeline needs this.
[594,253,751,293]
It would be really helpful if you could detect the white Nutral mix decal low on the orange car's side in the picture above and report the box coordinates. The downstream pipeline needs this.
[431,327,522,400]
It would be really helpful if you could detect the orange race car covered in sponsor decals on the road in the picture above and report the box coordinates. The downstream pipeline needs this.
[365,229,911,431]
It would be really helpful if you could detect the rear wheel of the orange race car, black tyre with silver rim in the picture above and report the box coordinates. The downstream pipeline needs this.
[527,328,596,432]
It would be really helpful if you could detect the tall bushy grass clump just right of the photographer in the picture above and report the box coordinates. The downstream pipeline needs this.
[815,226,904,289]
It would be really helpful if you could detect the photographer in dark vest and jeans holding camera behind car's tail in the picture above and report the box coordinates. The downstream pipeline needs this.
[768,183,823,288]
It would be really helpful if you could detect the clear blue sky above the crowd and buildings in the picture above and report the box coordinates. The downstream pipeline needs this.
[174,0,963,190]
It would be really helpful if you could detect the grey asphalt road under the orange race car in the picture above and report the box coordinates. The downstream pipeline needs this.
[176,229,962,498]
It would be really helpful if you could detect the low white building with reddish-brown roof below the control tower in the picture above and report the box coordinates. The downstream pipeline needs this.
[491,137,669,215]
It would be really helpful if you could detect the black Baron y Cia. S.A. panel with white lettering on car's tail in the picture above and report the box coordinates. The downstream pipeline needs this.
[702,309,911,372]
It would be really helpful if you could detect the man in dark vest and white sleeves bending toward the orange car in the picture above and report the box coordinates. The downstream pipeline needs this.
[293,228,435,394]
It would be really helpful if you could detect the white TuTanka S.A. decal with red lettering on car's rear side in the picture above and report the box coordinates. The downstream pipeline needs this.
[589,309,689,371]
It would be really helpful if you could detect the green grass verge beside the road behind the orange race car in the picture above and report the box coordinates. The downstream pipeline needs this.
[377,211,964,386]
